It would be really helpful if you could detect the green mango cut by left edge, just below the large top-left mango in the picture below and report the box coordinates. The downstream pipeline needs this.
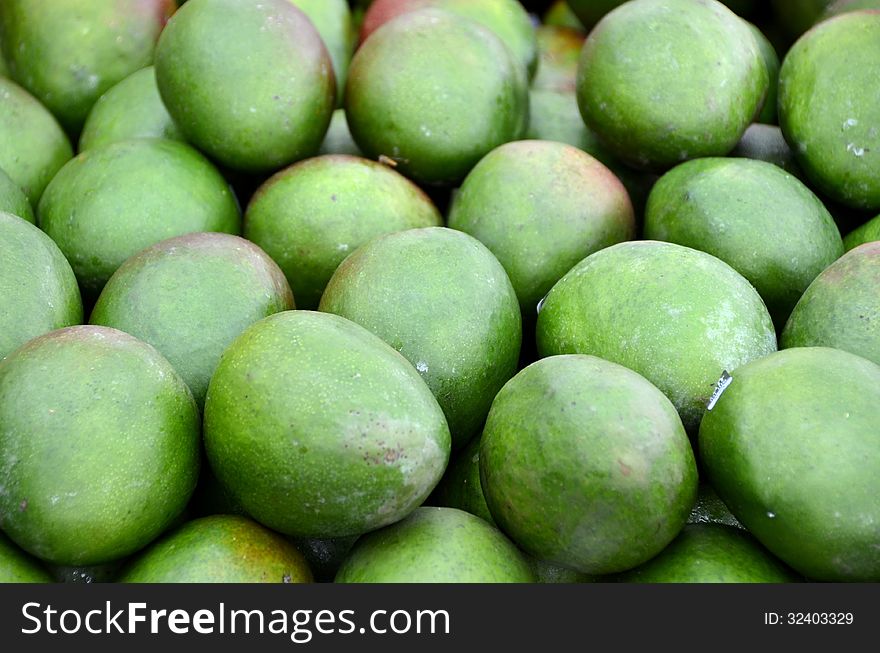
[0,77,73,207]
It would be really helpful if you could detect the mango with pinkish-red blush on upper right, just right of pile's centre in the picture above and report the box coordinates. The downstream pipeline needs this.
[448,141,636,317]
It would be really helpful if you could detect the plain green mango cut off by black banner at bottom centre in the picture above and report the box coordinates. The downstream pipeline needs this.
[336,508,535,583]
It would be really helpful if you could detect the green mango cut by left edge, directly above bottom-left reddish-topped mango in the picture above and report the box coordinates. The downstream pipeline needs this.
[0,212,83,359]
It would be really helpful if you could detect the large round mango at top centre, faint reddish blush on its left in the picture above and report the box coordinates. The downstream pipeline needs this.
[345,9,529,185]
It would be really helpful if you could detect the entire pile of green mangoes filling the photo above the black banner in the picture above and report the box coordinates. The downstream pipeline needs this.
[0,0,880,584]
